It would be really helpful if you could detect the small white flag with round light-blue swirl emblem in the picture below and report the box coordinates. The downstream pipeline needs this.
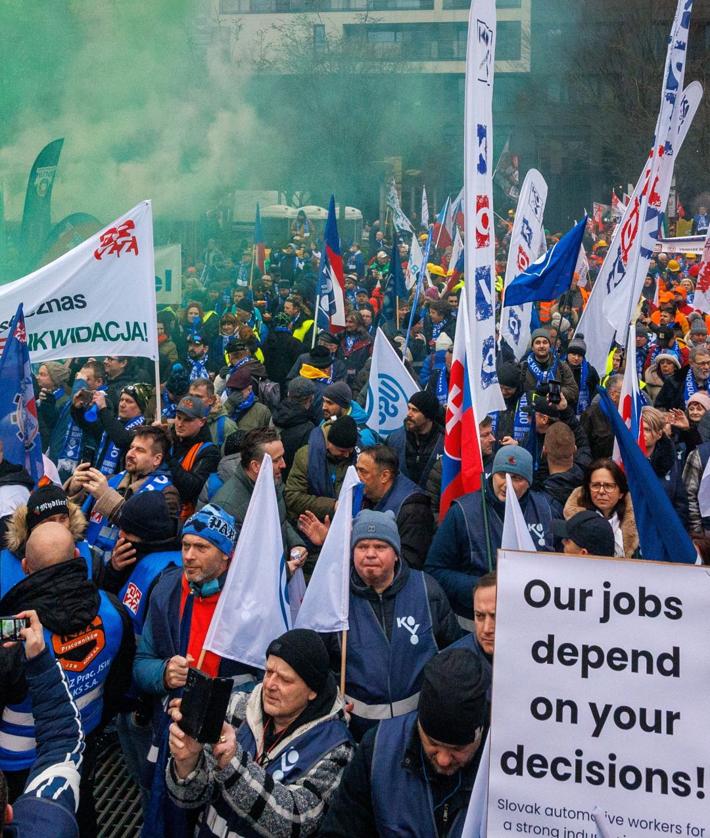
[365,329,419,436]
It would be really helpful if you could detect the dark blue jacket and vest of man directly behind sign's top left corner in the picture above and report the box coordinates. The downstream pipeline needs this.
[424,478,554,619]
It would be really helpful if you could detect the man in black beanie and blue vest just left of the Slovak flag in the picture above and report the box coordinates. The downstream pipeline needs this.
[387,390,444,506]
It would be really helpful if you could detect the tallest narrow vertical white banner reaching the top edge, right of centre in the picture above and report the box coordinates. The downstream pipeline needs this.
[468,0,505,417]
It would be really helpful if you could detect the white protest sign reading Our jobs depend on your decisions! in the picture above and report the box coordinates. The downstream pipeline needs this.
[488,550,710,838]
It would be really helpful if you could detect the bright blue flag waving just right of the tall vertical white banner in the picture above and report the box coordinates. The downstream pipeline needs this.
[505,215,587,306]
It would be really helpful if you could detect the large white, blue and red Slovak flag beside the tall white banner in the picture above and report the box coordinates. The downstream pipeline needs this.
[439,285,483,521]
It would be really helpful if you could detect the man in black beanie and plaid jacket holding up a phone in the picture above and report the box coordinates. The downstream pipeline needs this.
[166,629,359,835]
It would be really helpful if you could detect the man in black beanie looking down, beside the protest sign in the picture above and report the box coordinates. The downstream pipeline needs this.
[319,648,490,838]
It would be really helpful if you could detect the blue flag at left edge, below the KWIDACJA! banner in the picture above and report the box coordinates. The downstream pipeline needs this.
[0,303,44,482]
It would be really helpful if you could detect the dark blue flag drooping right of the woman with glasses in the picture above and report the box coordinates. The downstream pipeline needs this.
[599,387,696,564]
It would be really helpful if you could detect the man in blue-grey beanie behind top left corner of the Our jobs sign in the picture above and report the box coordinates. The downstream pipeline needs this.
[424,445,554,631]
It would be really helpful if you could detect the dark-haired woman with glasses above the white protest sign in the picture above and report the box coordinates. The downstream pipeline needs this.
[564,458,639,559]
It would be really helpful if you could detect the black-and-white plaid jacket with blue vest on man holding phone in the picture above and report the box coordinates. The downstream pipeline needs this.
[166,684,354,836]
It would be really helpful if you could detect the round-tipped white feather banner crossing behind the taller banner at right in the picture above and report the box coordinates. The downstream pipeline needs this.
[575,82,703,371]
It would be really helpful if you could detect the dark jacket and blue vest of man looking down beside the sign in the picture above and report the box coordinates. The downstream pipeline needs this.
[318,712,485,838]
